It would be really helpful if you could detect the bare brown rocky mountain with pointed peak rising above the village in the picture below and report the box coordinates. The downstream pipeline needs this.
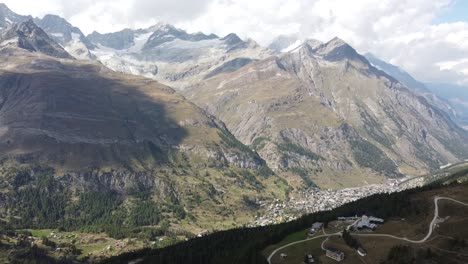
[184,38,468,187]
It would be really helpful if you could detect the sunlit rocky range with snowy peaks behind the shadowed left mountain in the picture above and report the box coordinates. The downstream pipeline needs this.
[0,4,467,192]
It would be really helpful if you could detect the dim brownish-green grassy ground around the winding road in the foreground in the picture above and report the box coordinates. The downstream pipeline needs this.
[263,185,468,263]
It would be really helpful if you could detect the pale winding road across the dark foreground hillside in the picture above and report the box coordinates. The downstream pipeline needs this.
[267,196,468,264]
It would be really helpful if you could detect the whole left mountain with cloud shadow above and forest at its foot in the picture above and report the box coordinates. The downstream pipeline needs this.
[0,20,288,235]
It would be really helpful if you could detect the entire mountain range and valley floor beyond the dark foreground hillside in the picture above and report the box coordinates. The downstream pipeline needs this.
[0,4,468,263]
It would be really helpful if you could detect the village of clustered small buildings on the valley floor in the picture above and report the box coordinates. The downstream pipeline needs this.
[249,175,423,227]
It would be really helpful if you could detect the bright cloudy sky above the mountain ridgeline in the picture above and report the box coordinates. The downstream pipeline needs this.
[0,0,468,86]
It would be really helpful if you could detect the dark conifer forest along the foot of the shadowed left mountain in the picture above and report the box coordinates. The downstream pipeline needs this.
[5,169,174,238]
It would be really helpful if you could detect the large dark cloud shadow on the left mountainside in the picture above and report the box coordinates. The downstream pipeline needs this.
[0,61,187,169]
